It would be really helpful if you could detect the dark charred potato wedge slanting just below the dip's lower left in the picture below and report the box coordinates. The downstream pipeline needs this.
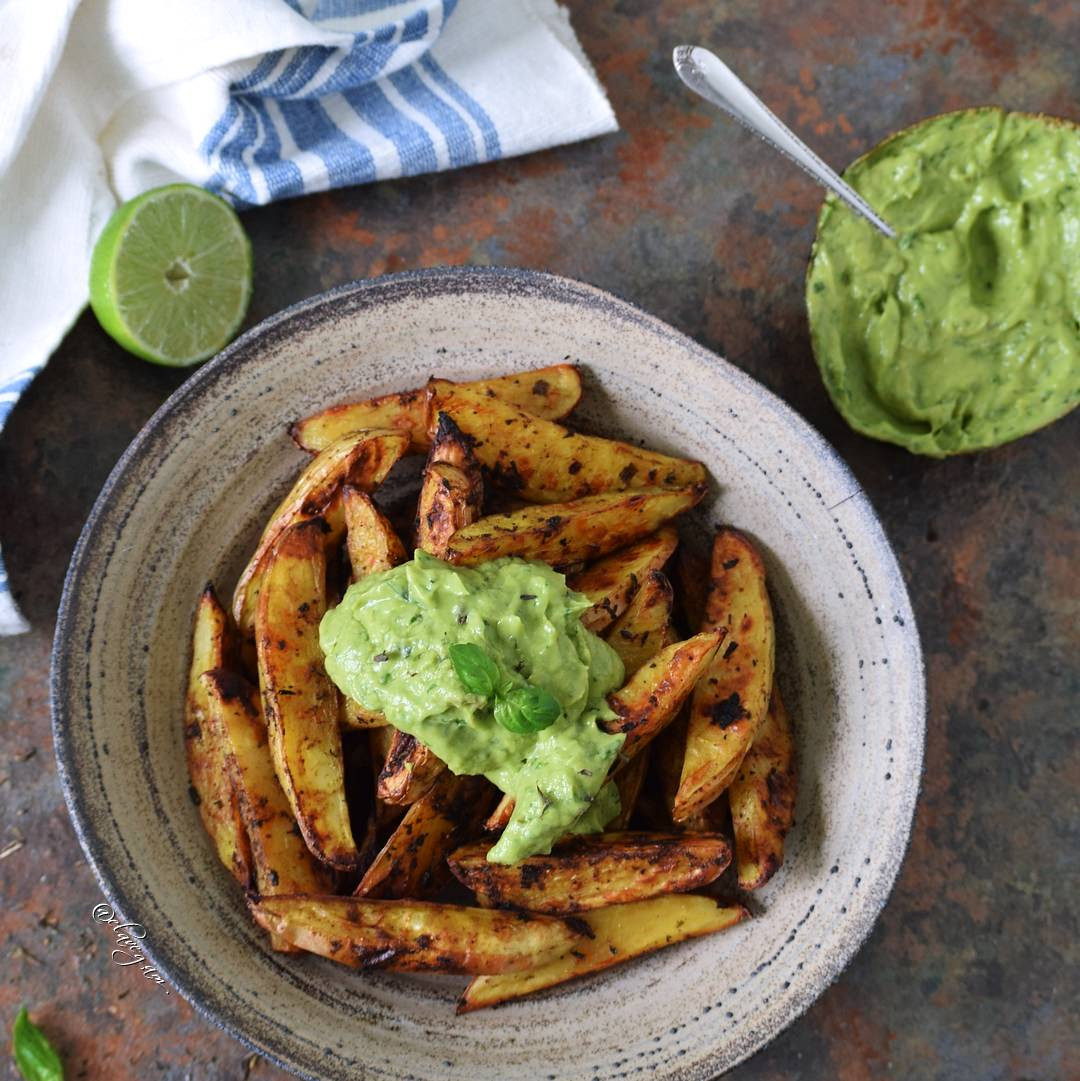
[355,770,494,899]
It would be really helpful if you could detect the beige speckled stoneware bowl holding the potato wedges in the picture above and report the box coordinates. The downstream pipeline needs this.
[53,269,924,1081]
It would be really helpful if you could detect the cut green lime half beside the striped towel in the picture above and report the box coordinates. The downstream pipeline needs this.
[90,184,251,368]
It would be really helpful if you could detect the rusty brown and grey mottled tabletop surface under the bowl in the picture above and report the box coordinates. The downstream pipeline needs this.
[0,0,1080,1081]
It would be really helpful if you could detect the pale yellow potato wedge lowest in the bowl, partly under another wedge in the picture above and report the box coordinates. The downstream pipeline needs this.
[457,894,750,1013]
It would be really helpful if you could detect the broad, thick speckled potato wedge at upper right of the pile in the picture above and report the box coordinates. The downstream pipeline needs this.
[430,379,705,505]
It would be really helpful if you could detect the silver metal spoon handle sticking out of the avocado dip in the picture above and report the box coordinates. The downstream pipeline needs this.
[672,45,896,239]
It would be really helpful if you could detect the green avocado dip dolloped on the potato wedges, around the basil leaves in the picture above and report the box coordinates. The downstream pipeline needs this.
[319,551,625,864]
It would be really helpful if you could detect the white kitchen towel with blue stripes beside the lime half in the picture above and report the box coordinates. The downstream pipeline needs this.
[0,0,616,633]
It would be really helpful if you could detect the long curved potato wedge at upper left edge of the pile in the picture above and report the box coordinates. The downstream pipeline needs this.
[232,428,409,635]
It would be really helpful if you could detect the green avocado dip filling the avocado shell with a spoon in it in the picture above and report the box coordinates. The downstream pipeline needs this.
[806,108,1080,457]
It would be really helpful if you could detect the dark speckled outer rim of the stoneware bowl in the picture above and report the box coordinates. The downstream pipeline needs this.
[49,266,926,1081]
